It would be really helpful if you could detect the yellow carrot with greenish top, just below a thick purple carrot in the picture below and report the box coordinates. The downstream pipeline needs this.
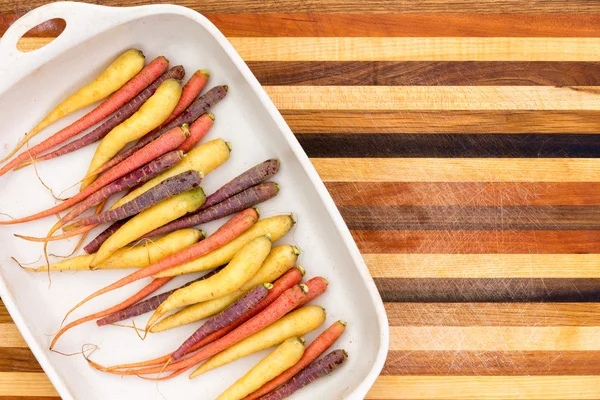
[90,187,205,267]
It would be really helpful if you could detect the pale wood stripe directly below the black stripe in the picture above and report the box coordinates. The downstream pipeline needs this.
[311,158,600,182]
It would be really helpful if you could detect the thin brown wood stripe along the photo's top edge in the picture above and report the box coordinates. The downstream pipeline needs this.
[0,0,600,14]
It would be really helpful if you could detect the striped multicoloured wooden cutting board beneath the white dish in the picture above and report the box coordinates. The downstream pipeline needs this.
[0,0,600,400]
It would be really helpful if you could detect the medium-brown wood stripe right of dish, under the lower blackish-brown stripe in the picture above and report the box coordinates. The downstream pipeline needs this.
[385,303,600,326]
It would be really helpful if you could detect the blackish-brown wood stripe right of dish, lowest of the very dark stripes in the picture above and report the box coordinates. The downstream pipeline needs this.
[375,278,600,303]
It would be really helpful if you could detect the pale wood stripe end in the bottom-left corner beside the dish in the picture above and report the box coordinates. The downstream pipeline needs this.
[0,372,58,397]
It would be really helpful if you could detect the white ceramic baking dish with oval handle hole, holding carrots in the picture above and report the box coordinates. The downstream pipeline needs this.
[0,2,389,400]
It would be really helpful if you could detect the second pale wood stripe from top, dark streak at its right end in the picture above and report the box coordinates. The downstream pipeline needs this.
[265,86,600,111]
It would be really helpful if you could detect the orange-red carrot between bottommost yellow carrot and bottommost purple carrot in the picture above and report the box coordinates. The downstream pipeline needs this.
[243,320,346,400]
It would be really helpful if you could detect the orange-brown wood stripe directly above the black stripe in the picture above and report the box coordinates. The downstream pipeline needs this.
[282,110,600,134]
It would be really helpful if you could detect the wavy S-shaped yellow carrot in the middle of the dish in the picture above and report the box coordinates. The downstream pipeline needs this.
[146,234,271,330]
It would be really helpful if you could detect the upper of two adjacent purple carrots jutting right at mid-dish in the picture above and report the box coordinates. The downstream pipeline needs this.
[198,159,280,211]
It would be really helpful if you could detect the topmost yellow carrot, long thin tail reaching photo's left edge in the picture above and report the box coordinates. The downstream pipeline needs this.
[0,49,145,163]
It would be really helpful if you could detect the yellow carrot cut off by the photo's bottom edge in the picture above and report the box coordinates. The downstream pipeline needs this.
[217,337,305,400]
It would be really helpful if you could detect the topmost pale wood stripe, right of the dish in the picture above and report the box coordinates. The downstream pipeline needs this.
[229,37,600,61]
